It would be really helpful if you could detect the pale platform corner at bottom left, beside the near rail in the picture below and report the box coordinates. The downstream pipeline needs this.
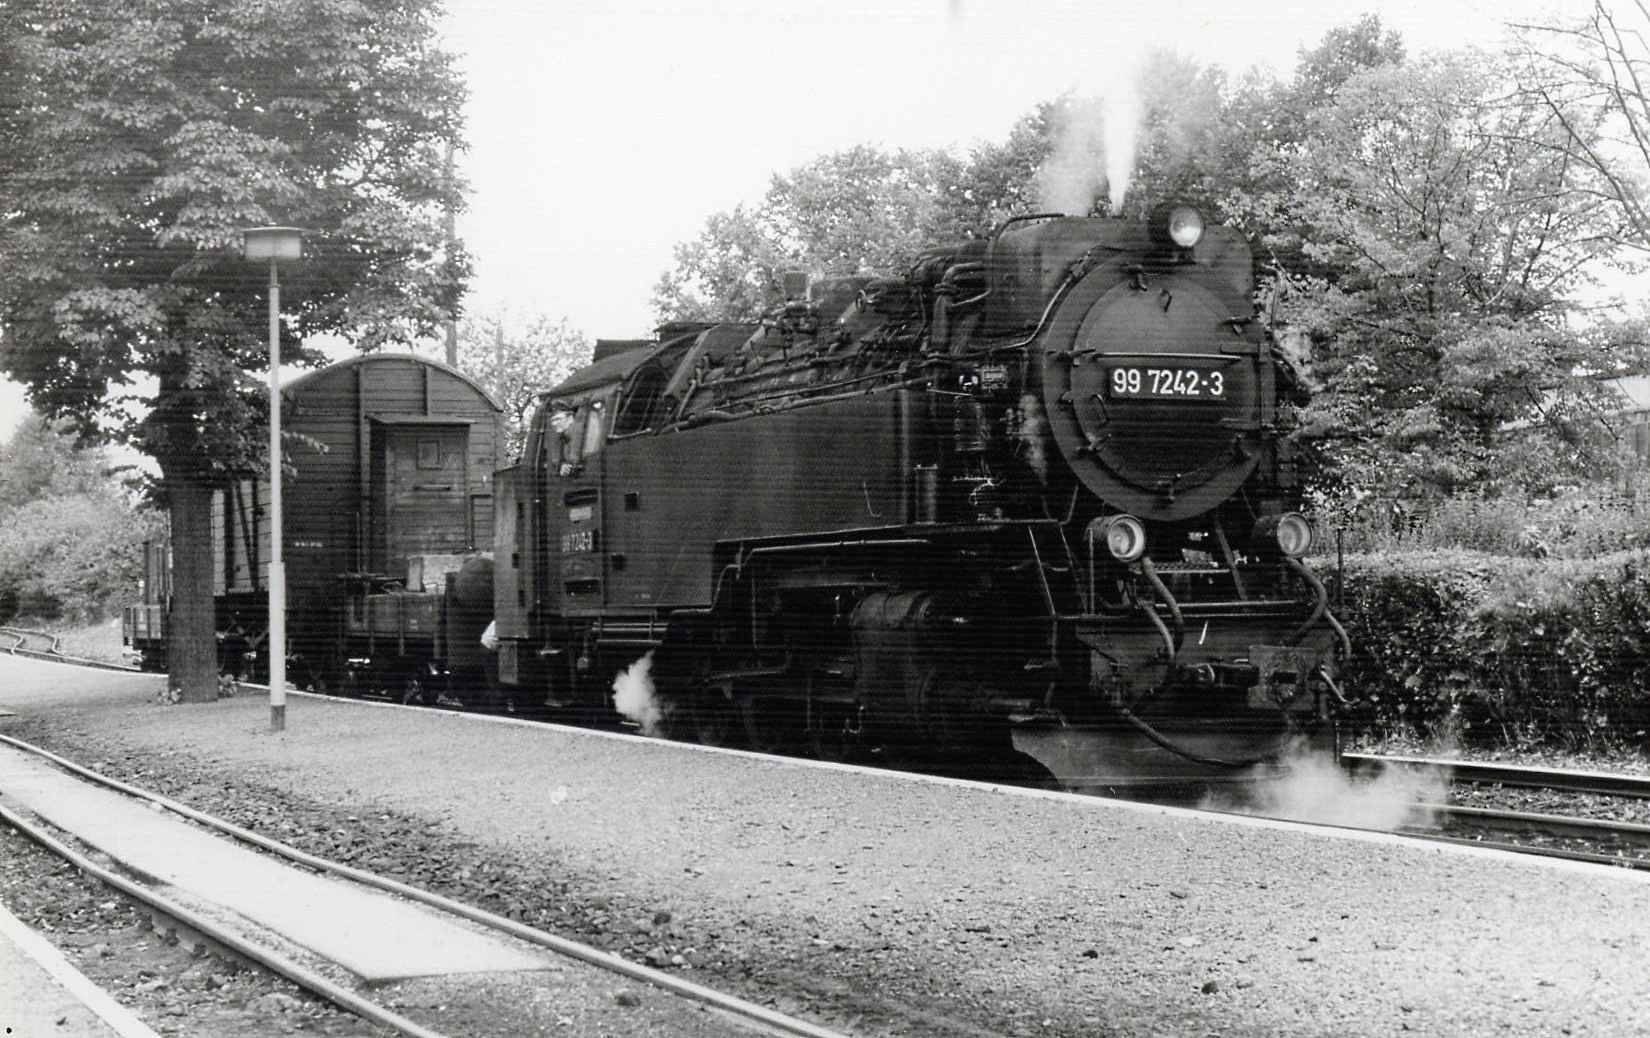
[0,908,158,1038]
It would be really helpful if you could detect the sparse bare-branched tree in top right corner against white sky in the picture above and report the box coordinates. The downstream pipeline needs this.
[1518,0,1650,254]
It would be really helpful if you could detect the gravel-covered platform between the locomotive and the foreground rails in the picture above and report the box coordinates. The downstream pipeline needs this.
[0,660,1650,1036]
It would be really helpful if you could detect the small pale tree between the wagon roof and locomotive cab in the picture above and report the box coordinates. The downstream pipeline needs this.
[459,312,594,457]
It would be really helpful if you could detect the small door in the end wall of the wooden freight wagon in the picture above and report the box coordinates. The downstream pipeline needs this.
[368,421,470,576]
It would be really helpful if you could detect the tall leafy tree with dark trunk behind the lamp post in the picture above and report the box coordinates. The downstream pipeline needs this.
[0,0,469,700]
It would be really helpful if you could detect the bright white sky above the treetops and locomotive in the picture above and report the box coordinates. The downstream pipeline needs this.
[0,0,1623,437]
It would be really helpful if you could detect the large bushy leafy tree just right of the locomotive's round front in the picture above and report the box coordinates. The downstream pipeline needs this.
[1256,53,1625,495]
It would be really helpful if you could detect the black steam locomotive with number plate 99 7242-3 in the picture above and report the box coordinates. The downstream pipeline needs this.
[493,208,1348,787]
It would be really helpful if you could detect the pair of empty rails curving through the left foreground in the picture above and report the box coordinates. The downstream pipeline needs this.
[0,734,842,1038]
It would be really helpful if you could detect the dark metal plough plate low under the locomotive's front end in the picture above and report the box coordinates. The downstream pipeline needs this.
[1011,720,1333,792]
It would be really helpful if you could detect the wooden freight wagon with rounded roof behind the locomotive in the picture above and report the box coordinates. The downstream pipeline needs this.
[213,353,502,688]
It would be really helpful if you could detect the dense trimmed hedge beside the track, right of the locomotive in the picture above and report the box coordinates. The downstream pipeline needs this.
[1337,550,1650,746]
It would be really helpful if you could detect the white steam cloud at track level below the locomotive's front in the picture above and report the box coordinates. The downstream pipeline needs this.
[1200,748,1449,832]
